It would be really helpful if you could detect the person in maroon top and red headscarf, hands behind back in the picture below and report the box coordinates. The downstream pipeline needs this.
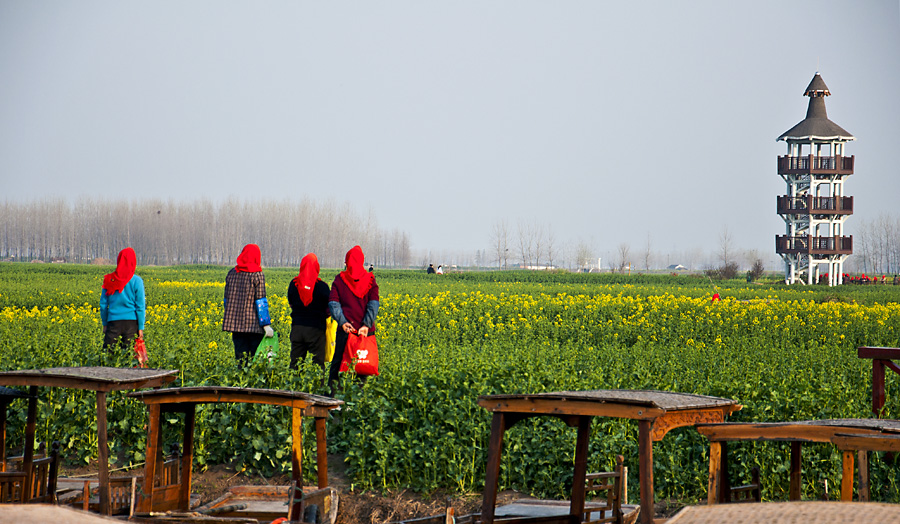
[328,246,379,396]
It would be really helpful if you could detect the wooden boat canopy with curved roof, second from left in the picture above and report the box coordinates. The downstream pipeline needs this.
[128,386,344,515]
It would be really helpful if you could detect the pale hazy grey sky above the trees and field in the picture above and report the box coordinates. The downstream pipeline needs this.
[0,0,900,259]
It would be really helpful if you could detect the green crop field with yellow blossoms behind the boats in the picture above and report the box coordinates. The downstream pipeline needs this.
[0,263,900,502]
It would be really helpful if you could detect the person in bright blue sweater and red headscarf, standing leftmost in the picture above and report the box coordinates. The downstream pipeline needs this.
[100,247,147,349]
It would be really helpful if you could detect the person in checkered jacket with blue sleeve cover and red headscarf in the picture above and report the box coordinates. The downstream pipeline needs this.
[222,244,275,363]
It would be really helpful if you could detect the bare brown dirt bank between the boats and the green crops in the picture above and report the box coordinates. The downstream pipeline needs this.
[60,455,683,524]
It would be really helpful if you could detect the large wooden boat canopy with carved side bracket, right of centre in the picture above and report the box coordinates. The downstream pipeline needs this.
[478,390,742,524]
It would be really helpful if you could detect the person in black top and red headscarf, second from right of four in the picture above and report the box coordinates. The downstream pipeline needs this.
[287,253,330,372]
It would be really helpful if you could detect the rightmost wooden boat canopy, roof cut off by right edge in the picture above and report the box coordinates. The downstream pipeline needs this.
[697,419,900,504]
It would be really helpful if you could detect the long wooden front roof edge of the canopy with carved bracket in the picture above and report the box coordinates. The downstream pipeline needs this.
[478,397,666,420]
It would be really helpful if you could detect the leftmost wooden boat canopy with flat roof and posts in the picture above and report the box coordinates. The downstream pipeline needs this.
[0,366,178,515]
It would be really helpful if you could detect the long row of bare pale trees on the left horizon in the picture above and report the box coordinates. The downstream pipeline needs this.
[0,198,411,268]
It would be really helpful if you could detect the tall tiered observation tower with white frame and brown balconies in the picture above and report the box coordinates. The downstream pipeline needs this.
[775,73,856,286]
